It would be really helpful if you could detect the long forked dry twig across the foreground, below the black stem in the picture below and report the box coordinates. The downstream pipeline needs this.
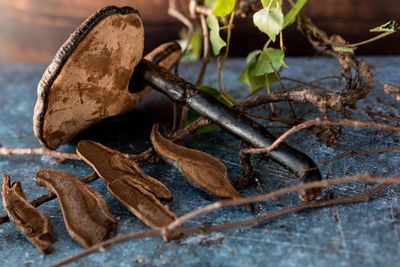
[51,175,394,267]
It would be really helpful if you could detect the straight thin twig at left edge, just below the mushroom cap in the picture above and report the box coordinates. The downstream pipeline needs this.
[0,147,80,160]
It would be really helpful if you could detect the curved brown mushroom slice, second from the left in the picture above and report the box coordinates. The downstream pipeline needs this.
[36,170,116,248]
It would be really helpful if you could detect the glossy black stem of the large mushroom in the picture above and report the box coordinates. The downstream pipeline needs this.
[129,59,321,199]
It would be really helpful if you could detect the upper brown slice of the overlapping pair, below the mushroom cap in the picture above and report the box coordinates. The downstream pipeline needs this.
[76,140,172,199]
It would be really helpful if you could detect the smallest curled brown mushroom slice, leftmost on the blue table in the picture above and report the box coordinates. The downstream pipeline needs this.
[2,176,53,254]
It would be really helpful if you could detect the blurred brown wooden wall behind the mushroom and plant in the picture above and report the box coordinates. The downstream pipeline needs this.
[0,0,400,63]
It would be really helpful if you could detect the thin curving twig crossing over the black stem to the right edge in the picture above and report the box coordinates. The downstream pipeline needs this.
[243,118,400,154]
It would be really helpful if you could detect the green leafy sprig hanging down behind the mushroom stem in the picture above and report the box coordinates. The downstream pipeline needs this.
[205,0,307,99]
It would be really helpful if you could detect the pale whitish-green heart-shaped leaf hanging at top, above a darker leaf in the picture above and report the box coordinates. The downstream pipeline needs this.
[253,7,283,42]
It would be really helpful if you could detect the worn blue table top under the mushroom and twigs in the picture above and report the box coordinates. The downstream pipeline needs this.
[0,57,400,266]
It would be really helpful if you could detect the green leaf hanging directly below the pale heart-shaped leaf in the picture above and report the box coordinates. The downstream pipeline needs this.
[249,47,285,76]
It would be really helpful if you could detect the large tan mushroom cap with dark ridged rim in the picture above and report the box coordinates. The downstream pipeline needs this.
[33,6,180,149]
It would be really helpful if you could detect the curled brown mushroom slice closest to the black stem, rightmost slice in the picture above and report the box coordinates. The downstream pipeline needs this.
[151,124,242,198]
